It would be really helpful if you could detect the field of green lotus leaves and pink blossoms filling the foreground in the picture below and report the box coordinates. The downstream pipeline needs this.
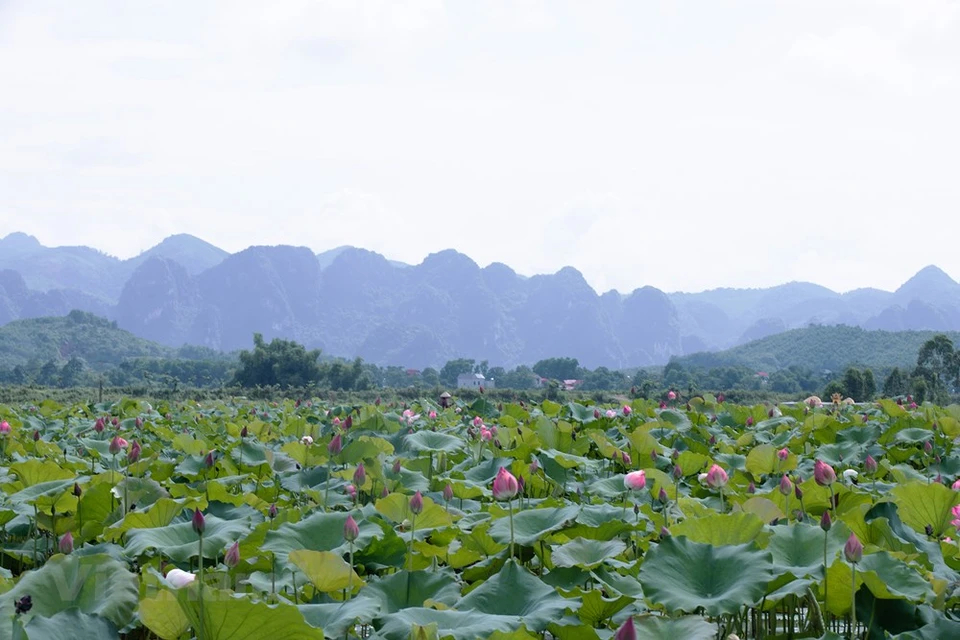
[0,396,960,640]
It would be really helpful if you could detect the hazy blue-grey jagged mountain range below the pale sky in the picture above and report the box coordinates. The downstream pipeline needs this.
[0,233,960,368]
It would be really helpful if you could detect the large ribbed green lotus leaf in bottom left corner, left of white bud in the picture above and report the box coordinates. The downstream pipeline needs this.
[0,554,139,631]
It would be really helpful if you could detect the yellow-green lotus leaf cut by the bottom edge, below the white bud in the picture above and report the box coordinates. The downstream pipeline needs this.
[177,583,318,640]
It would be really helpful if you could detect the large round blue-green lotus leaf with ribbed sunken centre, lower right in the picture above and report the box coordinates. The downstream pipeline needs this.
[640,537,774,616]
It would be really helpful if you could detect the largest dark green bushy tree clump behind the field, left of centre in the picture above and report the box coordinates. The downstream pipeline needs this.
[233,333,321,387]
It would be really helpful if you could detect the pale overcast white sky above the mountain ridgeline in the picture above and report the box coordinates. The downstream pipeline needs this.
[0,0,960,292]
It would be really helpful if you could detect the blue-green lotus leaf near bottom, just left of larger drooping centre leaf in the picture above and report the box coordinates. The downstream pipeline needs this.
[358,570,460,615]
